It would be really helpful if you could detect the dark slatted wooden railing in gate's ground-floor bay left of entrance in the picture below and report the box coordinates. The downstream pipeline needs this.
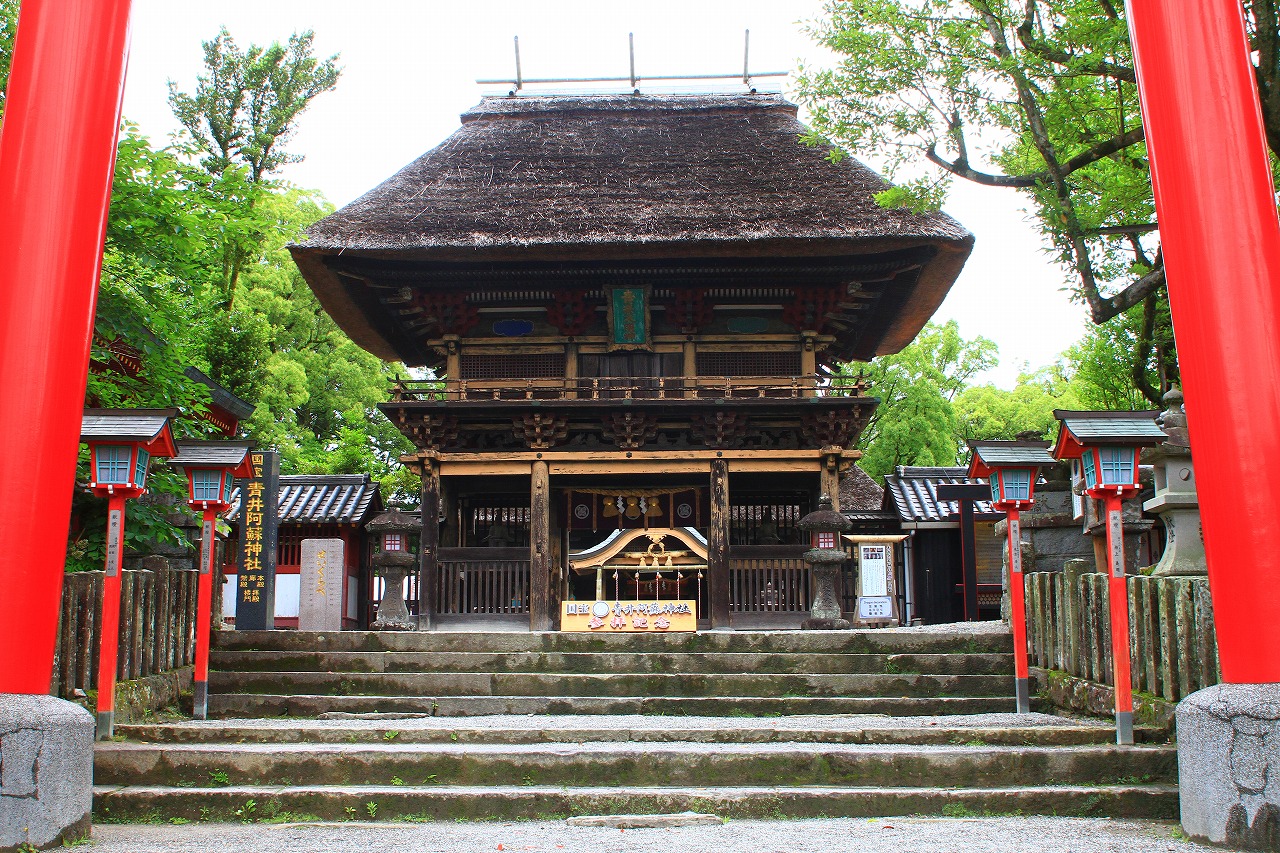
[435,548,529,616]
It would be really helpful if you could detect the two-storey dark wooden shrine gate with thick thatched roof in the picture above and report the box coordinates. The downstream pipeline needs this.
[291,93,973,630]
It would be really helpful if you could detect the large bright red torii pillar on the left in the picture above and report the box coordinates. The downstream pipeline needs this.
[0,0,129,693]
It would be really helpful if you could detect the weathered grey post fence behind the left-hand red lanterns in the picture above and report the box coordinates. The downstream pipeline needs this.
[50,569,198,698]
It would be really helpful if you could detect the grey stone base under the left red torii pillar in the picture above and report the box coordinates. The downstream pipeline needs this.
[0,693,93,850]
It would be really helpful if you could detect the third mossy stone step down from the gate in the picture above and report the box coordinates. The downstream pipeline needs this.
[209,671,1014,698]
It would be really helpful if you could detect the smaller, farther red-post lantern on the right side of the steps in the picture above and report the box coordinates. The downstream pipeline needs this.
[969,442,1057,713]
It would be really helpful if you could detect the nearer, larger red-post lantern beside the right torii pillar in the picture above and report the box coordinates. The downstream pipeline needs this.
[1053,410,1165,744]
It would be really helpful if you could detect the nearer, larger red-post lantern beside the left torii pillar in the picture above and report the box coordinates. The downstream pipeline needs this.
[81,409,178,740]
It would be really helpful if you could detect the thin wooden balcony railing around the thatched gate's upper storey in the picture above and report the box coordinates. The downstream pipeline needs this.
[392,375,867,402]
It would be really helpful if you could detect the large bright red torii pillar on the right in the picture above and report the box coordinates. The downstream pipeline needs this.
[1117,0,1280,686]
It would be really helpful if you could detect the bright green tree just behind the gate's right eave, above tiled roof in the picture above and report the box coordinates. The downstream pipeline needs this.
[844,320,996,478]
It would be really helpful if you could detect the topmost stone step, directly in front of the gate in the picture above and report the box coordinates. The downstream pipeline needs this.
[212,622,1012,654]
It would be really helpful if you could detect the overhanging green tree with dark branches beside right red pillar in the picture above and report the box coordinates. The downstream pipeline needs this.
[799,0,1244,402]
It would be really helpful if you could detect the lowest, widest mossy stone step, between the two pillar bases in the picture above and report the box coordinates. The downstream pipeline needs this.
[93,785,1178,822]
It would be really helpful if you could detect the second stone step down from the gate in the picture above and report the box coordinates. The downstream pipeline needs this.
[211,649,1014,675]
